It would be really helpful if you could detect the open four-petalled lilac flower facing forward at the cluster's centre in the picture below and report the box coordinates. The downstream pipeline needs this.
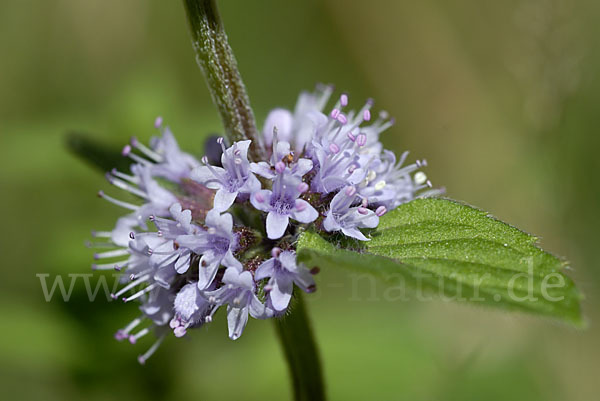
[250,168,319,239]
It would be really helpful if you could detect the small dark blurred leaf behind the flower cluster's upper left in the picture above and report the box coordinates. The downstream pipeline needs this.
[66,132,131,172]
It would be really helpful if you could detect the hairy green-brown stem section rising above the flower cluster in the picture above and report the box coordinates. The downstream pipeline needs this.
[183,0,263,161]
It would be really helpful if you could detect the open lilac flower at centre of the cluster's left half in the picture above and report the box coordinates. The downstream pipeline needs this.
[175,209,242,290]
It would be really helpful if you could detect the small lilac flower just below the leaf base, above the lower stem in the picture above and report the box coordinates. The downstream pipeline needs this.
[254,248,315,311]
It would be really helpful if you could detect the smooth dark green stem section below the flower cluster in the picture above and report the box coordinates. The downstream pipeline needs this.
[275,291,325,401]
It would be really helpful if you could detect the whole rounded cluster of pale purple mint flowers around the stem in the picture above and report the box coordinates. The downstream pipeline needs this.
[92,86,436,363]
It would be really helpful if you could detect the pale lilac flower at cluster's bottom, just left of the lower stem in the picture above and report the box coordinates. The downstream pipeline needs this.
[205,268,273,340]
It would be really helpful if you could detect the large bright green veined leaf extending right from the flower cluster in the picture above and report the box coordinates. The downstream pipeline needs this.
[297,198,583,326]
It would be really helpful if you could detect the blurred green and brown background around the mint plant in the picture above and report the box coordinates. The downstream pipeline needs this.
[0,0,600,401]
